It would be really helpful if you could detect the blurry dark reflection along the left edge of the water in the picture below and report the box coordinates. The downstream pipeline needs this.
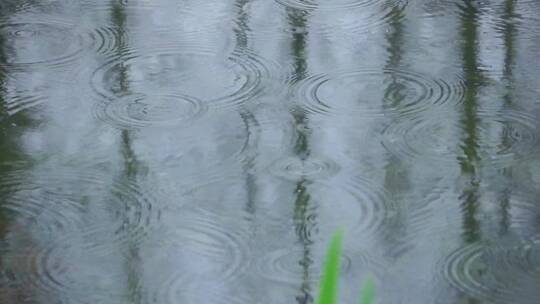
[0,9,36,303]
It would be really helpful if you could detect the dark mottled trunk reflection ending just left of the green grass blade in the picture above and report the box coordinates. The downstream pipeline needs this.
[287,9,315,304]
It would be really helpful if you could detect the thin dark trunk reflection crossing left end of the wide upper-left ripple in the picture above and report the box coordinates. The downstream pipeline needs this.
[111,0,142,304]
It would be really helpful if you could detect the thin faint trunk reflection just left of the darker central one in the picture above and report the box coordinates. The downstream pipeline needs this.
[234,0,258,216]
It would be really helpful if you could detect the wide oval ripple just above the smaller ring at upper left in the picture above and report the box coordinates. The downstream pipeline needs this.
[92,47,276,112]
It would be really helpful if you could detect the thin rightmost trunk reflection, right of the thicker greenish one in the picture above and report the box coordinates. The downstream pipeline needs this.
[499,0,517,234]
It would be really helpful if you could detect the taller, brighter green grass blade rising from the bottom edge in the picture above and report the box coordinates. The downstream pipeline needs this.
[317,230,343,304]
